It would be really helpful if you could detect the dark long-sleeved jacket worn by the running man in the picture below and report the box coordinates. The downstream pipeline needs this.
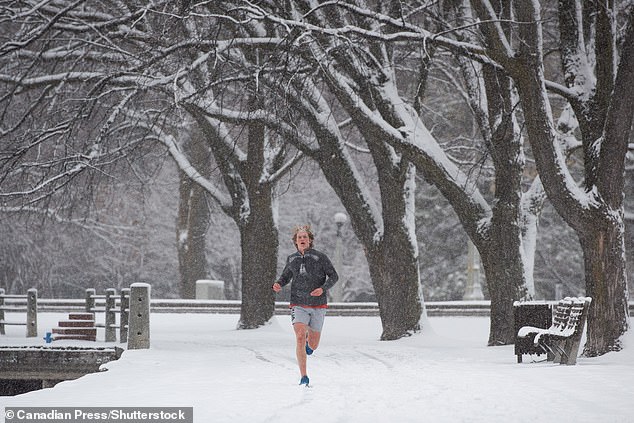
[278,248,339,307]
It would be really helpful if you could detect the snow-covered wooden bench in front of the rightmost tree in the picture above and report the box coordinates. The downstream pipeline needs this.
[517,297,592,364]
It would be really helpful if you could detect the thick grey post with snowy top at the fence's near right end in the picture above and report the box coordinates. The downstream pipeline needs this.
[128,283,150,350]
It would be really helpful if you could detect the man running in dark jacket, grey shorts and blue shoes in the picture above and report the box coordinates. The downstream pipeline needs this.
[273,225,339,386]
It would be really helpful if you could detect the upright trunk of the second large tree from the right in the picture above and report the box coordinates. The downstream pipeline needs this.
[474,58,534,346]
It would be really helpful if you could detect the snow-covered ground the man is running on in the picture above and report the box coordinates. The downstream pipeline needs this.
[0,313,634,423]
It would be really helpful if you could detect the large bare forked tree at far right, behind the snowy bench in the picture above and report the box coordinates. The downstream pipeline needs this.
[508,1,634,356]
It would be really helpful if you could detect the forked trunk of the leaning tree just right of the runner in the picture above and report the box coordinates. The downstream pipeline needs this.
[320,134,422,340]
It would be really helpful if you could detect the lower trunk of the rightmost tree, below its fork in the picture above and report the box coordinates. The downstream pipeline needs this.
[580,219,629,357]
